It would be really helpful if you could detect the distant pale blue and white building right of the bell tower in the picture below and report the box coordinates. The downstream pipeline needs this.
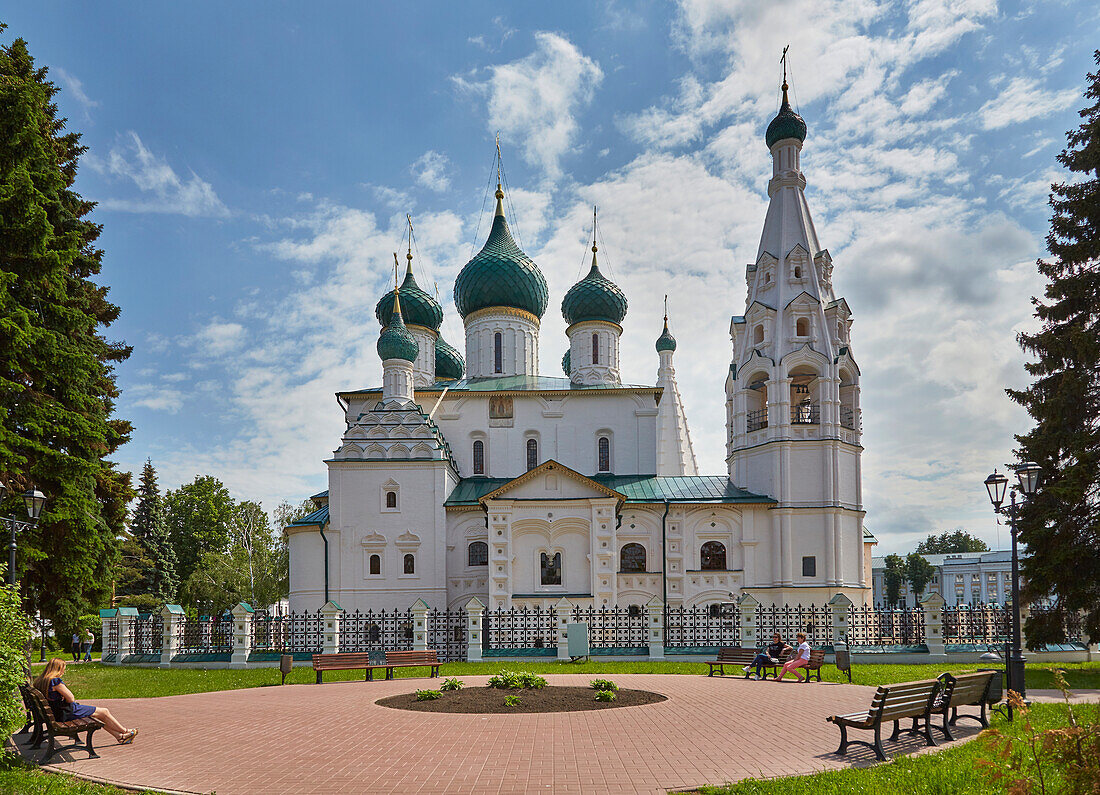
[871,550,1012,607]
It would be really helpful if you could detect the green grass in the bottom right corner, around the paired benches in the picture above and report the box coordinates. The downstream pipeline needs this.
[695,704,1082,795]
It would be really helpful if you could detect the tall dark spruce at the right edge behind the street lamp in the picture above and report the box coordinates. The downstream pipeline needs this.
[1009,51,1100,642]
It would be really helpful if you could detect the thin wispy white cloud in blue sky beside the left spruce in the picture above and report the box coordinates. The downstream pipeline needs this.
[85,130,229,218]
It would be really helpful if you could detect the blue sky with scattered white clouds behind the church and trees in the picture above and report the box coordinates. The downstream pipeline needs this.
[3,0,1100,552]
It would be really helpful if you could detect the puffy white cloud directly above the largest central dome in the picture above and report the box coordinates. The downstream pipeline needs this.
[452,32,604,179]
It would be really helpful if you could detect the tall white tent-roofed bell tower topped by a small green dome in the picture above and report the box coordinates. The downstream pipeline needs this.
[726,66,869,604]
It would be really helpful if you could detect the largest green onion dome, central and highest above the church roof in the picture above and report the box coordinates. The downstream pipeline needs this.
[454,186,550,318]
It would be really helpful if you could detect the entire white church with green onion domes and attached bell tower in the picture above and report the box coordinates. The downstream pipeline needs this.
[286,81,873,610]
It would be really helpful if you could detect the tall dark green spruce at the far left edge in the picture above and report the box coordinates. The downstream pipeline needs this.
[0,26,132,634]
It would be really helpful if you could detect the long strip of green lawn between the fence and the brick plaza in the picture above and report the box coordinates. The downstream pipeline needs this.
[27,660,1100,700]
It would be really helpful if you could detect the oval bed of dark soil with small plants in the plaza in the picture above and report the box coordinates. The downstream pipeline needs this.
[375,686,667,714]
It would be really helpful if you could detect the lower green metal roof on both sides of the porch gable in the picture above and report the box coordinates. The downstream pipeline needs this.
[444,475,776,507]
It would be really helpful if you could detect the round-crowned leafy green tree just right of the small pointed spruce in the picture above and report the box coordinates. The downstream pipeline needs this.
[164,475,235,583]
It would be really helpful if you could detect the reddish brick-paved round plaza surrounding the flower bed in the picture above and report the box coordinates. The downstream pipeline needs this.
[10,674,990,795]
